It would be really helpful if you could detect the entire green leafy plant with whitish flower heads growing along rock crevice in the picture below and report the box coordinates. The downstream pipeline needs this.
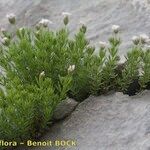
[0,12,150,147]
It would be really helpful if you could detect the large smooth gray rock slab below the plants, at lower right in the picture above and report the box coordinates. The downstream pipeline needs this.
[24,91,150,150]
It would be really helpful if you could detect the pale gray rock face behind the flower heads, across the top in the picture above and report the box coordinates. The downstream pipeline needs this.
[0,0,150,56]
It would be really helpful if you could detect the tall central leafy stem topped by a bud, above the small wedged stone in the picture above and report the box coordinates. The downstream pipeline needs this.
[69,26,89,101]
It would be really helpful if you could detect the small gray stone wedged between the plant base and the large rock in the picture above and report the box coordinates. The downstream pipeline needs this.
[53,98,78,120]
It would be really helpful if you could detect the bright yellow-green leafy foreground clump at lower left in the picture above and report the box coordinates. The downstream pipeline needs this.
[0,75,71,140]
